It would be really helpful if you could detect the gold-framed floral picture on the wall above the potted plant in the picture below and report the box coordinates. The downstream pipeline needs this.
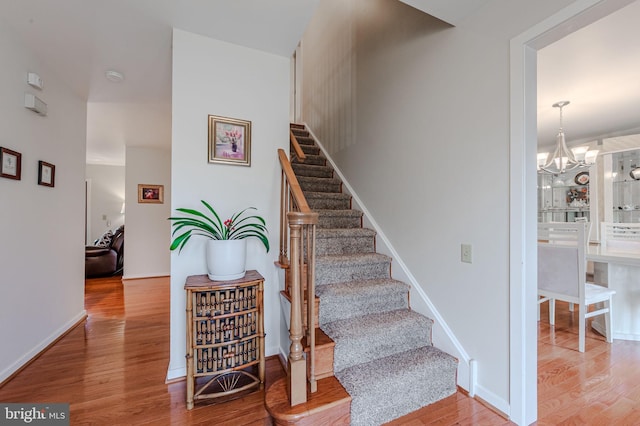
[209,115,251,166]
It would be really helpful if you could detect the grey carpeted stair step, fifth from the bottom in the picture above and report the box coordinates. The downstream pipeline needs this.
[316,228,376,256]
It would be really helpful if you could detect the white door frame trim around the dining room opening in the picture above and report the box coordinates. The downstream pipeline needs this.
[509,0,632,424]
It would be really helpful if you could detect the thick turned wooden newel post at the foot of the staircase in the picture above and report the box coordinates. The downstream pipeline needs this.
[287,212,307,406]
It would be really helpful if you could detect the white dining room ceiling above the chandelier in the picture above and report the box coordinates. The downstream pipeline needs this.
[538,1,640,151]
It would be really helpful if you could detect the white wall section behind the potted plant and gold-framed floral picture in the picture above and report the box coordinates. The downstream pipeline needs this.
[169,29,293,378]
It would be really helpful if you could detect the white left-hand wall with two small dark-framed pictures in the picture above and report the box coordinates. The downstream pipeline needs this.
[0,25,86,381]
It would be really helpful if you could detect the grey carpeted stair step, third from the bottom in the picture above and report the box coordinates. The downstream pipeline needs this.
[316,278,409,326]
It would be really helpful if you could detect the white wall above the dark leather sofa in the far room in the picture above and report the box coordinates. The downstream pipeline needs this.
[86,164,125,244]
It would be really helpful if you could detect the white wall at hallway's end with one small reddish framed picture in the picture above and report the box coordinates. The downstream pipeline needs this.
[123,147,171,279]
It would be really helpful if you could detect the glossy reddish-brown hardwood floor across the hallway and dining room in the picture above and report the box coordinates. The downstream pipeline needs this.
[0,277,640,426]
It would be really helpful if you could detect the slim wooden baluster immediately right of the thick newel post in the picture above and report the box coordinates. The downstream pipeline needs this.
[306,221,318,393]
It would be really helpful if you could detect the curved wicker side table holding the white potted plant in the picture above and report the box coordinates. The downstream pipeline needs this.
[184,271,265,410]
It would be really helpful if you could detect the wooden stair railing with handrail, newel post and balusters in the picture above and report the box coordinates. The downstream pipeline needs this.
[277,142,318,406]
